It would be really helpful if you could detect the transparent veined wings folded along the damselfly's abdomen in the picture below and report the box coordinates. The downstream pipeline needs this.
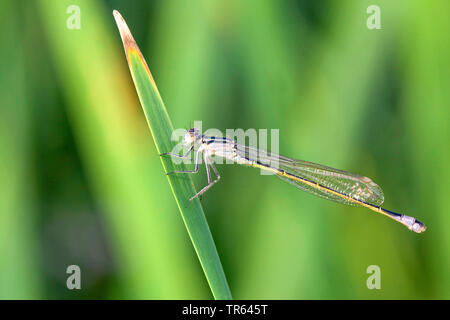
[237,145,384,206]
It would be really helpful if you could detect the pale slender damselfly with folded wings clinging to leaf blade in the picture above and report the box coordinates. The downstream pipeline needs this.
[161,128,426,233]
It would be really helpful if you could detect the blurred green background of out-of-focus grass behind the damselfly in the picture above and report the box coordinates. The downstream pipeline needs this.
[0,0,450,299]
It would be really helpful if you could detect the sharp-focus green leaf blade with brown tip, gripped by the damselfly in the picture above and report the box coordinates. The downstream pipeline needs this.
[113,10,232,300]
